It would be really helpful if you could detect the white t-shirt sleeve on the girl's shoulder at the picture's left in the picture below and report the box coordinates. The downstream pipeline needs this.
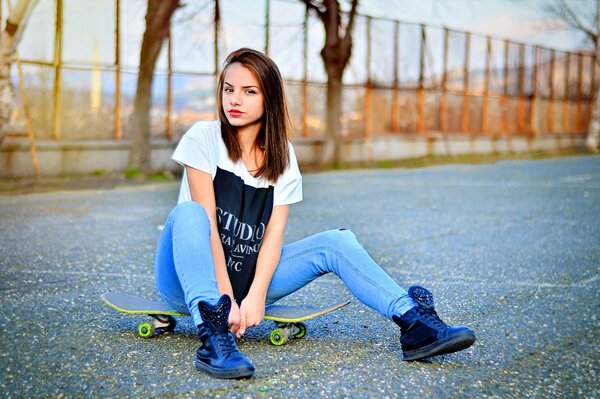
[172,122,217,176]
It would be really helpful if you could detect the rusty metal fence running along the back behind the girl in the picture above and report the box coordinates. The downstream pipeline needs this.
[7,0,598,144]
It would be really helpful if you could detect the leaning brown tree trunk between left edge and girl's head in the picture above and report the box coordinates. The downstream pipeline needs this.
[127,0,180,173]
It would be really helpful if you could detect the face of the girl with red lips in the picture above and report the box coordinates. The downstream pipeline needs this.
[221,62,265,128]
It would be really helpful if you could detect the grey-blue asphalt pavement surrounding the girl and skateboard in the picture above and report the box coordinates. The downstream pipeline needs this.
[0,156,600,398]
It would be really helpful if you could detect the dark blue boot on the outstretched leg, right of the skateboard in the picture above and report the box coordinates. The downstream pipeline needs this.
[393,286,475,360]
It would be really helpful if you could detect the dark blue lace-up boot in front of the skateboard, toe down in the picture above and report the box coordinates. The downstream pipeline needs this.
[194,295,254,378]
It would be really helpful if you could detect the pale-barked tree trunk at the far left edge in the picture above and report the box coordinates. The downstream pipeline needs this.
[0,0,38,143]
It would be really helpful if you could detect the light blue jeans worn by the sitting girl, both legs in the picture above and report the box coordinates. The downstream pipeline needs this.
[155,201,416,325]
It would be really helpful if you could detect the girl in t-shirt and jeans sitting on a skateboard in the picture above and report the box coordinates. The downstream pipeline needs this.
[155,48,475,378]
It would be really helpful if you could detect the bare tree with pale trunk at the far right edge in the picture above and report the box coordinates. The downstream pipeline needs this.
[545,0,600,152]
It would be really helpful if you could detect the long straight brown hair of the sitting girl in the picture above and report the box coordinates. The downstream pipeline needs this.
[217,48,290,182]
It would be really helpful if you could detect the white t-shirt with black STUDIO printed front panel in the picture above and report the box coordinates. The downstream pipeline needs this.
[173,121,302,302]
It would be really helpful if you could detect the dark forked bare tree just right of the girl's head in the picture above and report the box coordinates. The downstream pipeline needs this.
[302,0,358,165]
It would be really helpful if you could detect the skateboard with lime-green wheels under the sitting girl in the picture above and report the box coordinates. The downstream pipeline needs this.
[100,292,350,346]
